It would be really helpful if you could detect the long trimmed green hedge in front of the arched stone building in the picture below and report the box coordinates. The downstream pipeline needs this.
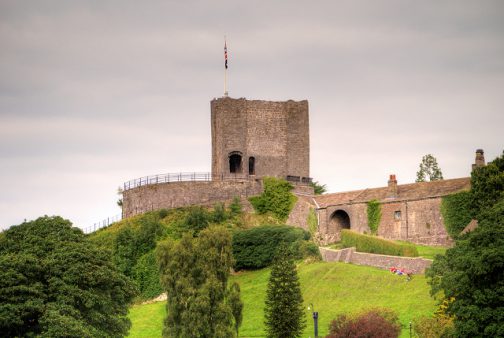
[341,229,418,257]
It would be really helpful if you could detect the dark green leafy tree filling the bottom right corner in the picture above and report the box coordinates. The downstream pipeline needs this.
[427,198,504,337]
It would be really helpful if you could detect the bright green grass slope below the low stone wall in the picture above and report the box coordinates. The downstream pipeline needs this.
[130,262,435,337]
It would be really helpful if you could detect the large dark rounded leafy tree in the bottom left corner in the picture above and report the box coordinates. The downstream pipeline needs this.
[0,216,136,337]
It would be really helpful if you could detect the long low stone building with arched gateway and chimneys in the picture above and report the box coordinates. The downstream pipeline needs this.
[313,149,485,245]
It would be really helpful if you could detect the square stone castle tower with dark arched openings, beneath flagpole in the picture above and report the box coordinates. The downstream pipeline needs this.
[211,97,310,180]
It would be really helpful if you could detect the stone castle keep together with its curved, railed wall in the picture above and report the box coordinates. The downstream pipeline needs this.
[123,97,313,219]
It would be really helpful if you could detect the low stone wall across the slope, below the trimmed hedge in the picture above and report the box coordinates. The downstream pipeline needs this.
[320,248,432,273]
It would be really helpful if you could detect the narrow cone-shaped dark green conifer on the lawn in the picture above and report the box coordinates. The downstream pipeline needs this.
[264,243,306,338]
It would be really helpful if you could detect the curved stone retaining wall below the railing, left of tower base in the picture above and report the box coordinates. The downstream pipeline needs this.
[123,180,262,218]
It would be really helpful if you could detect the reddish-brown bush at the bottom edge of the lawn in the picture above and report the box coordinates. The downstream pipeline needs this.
[326,308,401,338]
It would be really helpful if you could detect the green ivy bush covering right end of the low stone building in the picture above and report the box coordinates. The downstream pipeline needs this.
[441,191,472,238]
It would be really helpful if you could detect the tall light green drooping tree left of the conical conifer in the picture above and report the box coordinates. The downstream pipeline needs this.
[157,226,241,338]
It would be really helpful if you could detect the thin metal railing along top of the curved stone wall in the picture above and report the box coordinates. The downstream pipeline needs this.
[123,172,255,191]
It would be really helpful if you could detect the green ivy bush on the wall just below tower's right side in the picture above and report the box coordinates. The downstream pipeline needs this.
[249,177,296,221]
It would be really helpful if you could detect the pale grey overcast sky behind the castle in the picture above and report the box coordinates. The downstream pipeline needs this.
[0,0,504,228]
